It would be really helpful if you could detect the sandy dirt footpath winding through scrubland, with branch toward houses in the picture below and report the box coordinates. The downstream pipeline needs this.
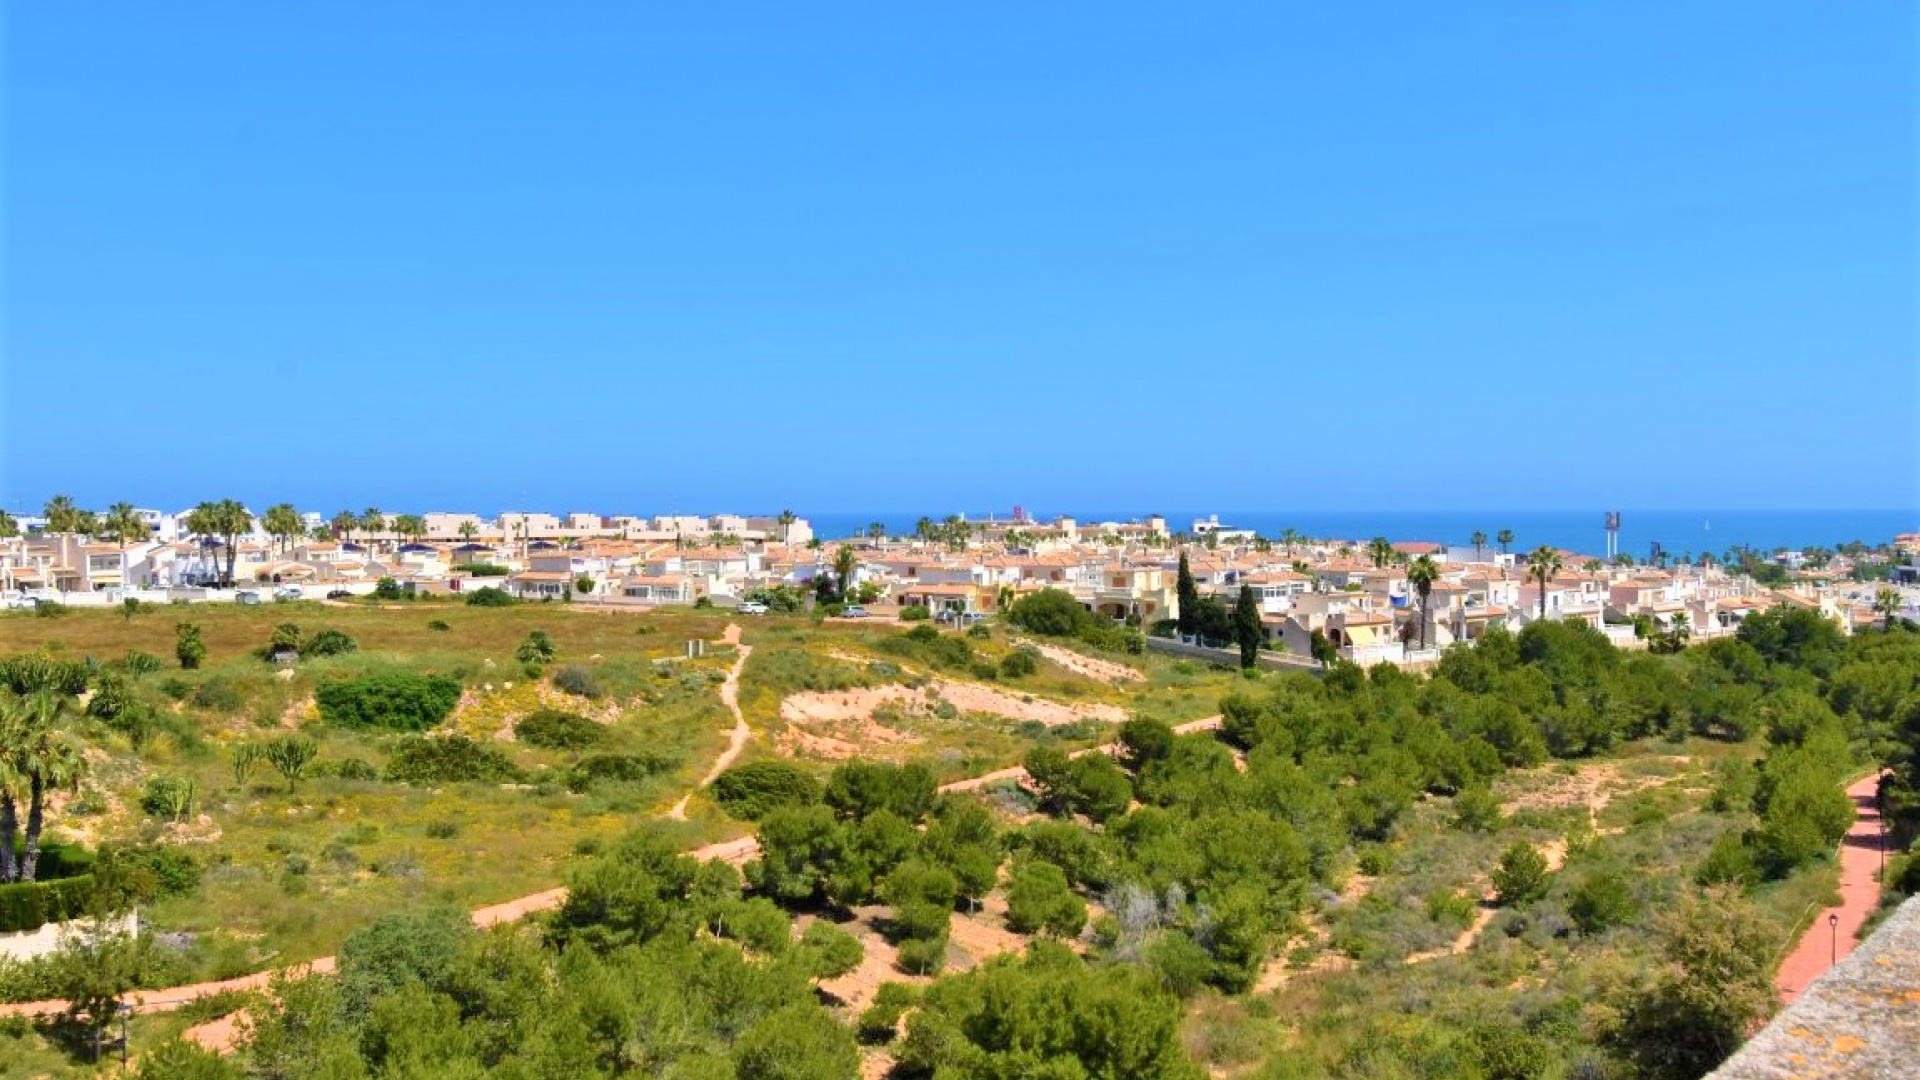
[0,611,1221,1022]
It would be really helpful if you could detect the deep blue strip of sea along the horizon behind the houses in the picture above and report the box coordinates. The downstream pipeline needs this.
[806,507,1920,559]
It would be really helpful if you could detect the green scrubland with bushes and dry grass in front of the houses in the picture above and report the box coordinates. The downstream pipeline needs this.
[0,605,1920,1080]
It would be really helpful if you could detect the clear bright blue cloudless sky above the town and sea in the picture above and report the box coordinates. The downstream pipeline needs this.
[0,2,1920,513]
